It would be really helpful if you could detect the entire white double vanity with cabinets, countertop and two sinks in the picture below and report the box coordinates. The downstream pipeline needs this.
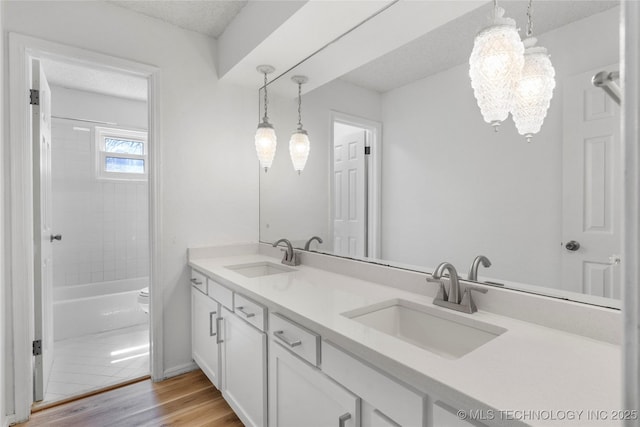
[189,245,621,427]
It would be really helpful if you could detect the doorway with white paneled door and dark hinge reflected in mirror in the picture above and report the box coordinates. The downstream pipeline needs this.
[329,112,381,258]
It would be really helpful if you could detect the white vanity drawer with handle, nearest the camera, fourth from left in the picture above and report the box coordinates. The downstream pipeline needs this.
[269,314,320,366]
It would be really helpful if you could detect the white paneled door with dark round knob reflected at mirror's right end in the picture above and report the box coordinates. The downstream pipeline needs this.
[562,64,622,298]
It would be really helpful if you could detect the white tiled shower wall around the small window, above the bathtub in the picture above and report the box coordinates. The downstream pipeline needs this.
[52,119,149,286]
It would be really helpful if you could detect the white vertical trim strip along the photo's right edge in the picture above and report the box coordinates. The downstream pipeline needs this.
[620,1,640,427]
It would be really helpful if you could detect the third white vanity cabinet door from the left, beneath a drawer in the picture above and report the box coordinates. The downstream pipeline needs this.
[269,342,360,427]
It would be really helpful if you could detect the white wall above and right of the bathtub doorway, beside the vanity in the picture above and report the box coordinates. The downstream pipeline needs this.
[3,1,258,414]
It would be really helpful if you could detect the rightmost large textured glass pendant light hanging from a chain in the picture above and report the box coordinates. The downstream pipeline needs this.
[511,0,556,142]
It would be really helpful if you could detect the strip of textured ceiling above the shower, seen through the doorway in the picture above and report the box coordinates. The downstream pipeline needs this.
[42,59,147,101]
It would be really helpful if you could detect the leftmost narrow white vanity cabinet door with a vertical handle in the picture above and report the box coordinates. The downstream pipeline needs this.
[191,288,220,388]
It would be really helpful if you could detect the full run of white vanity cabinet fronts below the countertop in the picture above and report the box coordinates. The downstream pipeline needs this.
[191,264,486,427]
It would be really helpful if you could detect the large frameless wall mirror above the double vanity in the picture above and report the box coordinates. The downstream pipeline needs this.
[260,0,624,307]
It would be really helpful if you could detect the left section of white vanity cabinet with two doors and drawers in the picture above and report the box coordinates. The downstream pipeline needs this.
[191,270,267,427]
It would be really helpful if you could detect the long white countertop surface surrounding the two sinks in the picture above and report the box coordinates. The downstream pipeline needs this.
[189,254,622,426]
